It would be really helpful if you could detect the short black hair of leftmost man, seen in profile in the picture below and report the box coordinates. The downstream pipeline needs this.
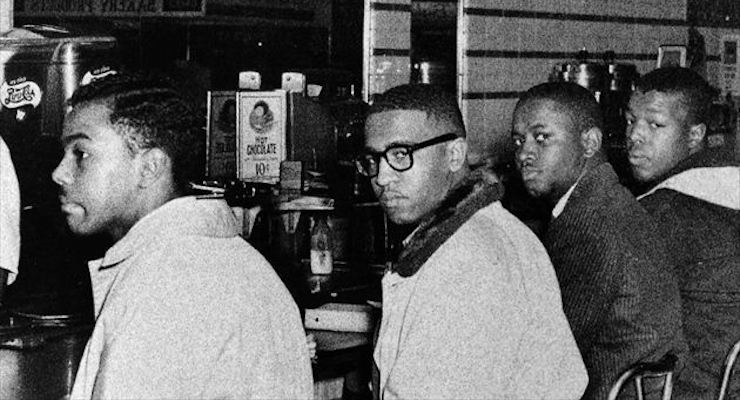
[68,72,205,197]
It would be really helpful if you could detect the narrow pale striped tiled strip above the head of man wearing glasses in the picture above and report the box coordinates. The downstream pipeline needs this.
[363,0,411,101]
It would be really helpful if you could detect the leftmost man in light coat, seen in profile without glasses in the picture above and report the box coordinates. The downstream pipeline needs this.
[52,74,313,399]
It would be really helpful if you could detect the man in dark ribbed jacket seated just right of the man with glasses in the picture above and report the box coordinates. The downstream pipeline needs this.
[512,82,686,399]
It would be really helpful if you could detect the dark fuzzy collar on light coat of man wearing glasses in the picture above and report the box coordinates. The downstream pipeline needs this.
[391,167,503,277]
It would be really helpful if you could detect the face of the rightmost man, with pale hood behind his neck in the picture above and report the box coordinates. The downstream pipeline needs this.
[625,91,690,182]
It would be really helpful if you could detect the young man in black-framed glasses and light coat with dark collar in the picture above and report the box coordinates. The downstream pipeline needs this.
[357,85,587,400]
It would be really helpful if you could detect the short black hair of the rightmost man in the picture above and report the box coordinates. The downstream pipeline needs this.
[635,67,715,125]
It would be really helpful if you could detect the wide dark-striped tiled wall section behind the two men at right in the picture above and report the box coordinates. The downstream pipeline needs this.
[458,0,688,162]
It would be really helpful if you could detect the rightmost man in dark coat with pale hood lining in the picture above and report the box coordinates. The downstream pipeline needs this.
[626,68,740,399]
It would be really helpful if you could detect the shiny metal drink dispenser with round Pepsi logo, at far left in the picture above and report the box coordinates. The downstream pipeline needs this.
[0,26,117,206]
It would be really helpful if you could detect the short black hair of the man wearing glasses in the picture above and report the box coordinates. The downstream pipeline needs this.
[367,83,465,137]
